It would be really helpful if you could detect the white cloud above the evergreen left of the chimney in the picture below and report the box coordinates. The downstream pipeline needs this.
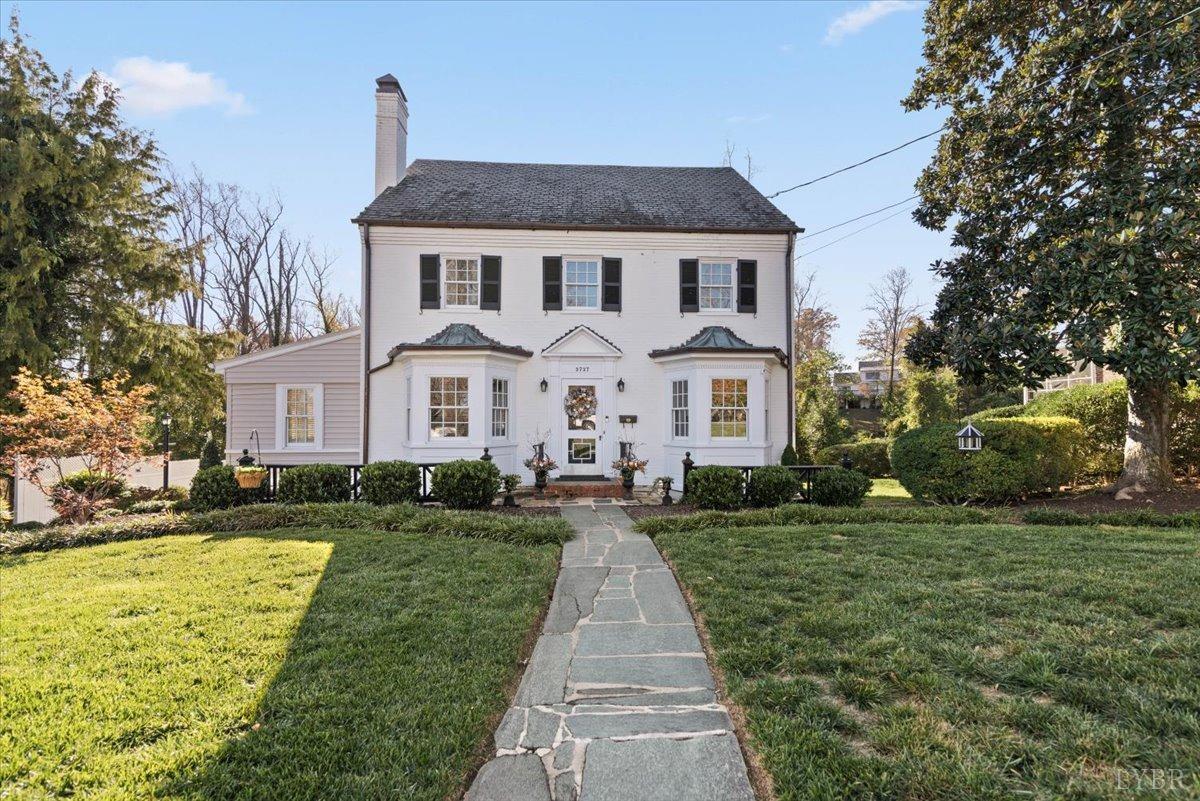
[100,55,253,115]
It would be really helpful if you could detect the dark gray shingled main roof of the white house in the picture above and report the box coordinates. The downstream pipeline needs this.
[354,158,798,233]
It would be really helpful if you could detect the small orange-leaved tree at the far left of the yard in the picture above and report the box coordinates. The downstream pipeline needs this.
[0,368,154,522]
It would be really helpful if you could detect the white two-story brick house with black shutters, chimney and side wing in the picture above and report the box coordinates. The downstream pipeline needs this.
[217,76,800,483]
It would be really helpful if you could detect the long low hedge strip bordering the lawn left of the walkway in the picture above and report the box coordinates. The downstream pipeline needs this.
[0,504,571,554]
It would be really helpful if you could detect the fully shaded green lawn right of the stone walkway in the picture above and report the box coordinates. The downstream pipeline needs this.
[656,524,1200,801]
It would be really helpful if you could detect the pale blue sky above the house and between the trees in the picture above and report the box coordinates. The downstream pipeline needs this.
[14,0,949,359]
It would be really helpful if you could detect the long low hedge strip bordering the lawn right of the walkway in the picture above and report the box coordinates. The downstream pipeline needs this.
[634,504,1013,536]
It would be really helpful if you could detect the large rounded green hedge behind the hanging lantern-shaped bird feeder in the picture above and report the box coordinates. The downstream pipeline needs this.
[892,417,1084,504]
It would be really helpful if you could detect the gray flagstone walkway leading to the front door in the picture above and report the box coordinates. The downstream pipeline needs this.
[467,504,754,801]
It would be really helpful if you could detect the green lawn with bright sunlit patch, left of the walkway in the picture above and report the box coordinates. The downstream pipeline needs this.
[0,530,558,800]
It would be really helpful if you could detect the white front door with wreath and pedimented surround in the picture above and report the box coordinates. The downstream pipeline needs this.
[541,326,622,476]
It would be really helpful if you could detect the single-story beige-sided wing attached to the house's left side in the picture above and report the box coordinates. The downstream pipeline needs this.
[212,327,362,464]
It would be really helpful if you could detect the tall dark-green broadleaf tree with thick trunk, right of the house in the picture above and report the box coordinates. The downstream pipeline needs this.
[905,0,1200,489]
